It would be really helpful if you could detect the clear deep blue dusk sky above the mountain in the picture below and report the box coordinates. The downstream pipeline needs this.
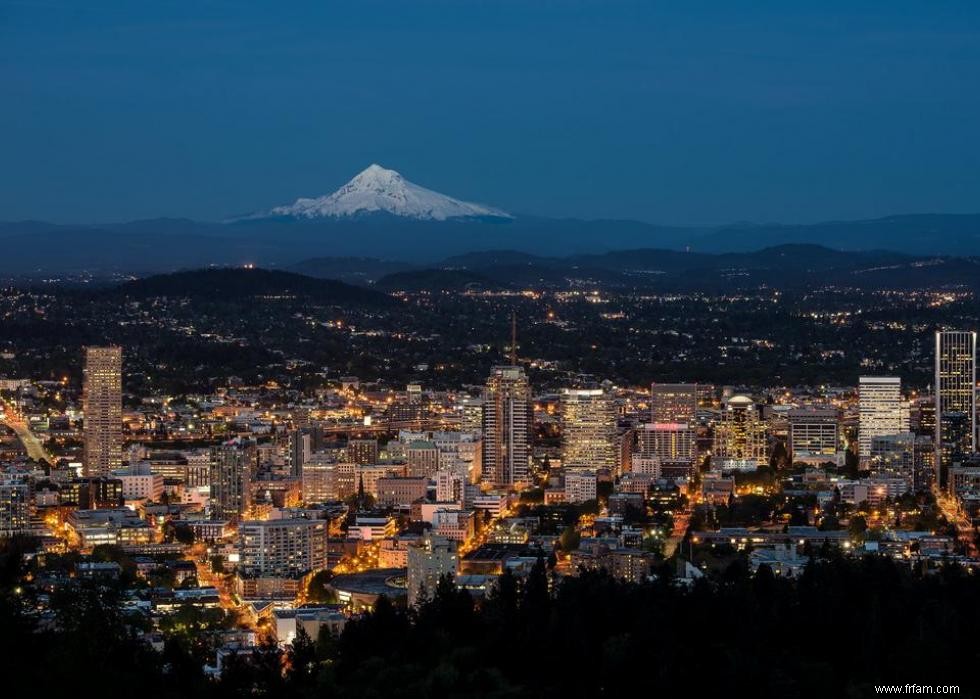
[0,0,980,223]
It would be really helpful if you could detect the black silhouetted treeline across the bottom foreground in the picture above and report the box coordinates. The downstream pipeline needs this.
[0,558,980,699]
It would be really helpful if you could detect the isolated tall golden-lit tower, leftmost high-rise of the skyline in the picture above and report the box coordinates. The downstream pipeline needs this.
[82,347,123,476]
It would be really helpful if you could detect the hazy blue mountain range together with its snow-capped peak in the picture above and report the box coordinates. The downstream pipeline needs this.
[0,165,980,279]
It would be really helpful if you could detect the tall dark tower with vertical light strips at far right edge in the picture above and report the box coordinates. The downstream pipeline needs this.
[934,330,977,485]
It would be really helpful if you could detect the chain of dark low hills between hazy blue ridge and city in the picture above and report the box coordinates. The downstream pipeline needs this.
[47,245,980,300]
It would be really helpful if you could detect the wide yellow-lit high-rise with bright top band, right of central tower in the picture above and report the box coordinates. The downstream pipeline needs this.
[561,388,619,470]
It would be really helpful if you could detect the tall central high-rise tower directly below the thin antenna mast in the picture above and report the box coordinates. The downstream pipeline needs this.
[483,366,533,488]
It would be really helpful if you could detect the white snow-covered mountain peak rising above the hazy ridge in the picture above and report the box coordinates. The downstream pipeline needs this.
[265,165,513,221]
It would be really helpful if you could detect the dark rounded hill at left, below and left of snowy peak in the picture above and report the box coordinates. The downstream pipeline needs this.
[98,268,392,306]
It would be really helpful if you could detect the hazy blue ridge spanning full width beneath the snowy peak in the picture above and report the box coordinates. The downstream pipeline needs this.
[0,211,980,282]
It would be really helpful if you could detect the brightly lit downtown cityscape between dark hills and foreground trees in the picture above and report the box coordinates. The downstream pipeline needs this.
[0,270,980,687]
